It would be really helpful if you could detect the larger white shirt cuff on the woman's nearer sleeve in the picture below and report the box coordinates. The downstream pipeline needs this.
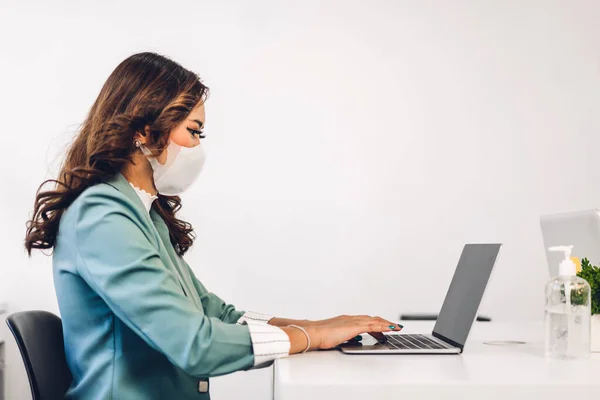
[237,314,291,367]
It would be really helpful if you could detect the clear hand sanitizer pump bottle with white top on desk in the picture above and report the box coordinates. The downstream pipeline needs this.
[545,246,591,358]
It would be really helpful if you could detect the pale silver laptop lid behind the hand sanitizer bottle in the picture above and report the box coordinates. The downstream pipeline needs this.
[540,210,600,277]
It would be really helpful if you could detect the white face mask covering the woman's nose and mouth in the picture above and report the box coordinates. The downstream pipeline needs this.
[141,141,206,196]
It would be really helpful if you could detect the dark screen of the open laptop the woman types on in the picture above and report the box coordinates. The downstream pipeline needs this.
[433,244,502,347]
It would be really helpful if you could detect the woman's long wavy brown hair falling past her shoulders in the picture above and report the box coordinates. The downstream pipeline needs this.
[25,52,208,256]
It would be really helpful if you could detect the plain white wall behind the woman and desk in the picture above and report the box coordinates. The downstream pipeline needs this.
[0,0,600,400]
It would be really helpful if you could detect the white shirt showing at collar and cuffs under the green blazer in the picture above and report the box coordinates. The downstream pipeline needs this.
[129,182,291,367]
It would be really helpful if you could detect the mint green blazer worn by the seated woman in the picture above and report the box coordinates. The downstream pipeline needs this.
[53,174,254,400]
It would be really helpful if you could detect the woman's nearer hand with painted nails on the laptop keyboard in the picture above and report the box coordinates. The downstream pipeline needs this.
[306,315,402,349]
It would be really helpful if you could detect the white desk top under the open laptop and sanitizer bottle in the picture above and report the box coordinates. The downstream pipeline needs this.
[274,321,600,400]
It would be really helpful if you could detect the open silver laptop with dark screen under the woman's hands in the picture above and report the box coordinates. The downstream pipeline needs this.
[339,244,502,354]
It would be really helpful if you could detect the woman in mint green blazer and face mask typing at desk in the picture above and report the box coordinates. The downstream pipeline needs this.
[25,53,400,399]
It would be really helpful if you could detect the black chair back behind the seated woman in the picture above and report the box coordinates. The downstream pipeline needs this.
[6,311,73,400]
